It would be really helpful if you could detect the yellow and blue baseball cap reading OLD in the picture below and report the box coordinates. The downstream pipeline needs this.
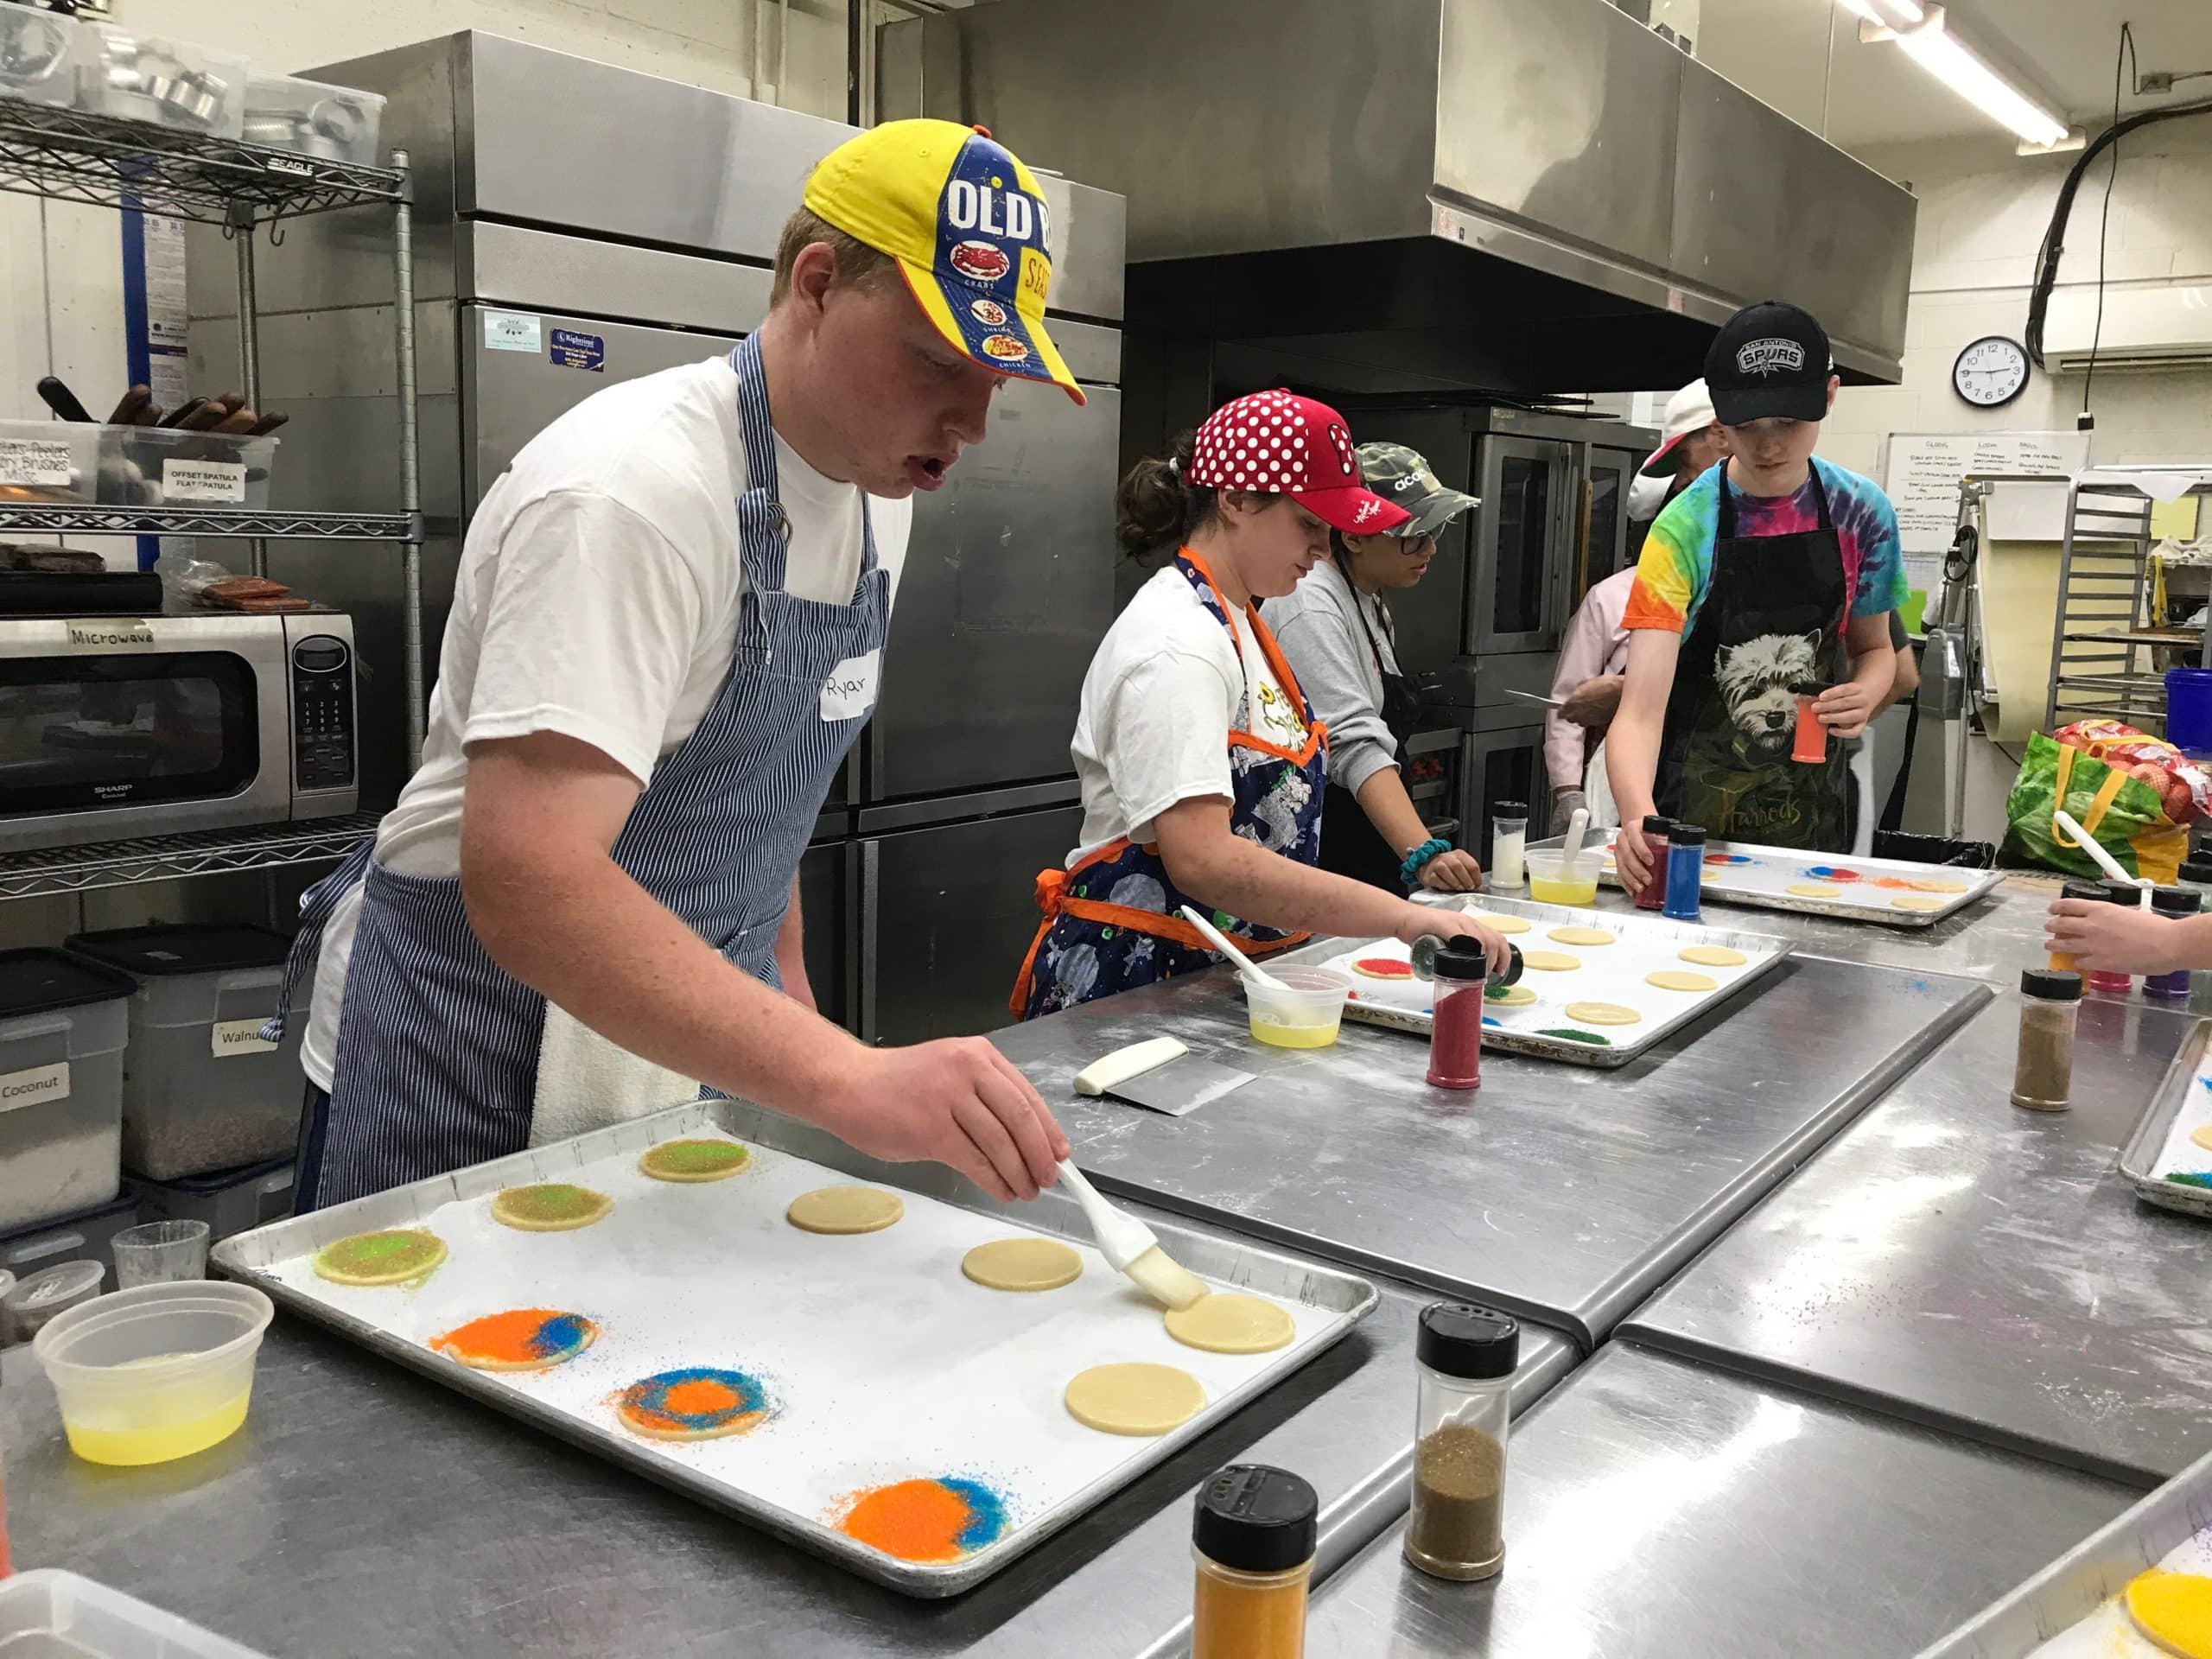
[805,119,1086,403]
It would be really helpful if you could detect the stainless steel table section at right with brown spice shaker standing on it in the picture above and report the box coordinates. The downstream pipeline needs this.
[1624,993,2212,1486]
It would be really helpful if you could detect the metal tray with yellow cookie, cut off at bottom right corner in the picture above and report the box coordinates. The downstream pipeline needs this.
[1918,1455,2212,1659]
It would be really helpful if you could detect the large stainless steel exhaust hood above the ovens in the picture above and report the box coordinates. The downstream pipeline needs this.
[878,0,1916,396]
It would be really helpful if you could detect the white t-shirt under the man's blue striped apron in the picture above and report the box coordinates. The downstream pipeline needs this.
[301,359,913,1089]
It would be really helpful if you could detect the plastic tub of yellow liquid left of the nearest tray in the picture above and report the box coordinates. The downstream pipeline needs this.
[31,1281,276,1465]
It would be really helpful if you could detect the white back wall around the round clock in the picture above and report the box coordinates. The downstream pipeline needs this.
[1822,118,2212,475]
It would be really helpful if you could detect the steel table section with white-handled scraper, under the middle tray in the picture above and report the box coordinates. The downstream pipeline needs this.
[991,960,1988,1347]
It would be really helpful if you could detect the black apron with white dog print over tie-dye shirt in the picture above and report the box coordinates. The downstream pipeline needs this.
[1655,469,1852,852]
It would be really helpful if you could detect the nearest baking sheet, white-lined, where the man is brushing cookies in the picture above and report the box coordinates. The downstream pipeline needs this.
[213,1099,1378,1597]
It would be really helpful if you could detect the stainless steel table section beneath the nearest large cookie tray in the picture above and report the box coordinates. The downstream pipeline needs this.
[0,1224,1575,1659]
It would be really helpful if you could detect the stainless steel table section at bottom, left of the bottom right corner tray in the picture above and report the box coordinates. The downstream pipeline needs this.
[1305,1343,2137,1659]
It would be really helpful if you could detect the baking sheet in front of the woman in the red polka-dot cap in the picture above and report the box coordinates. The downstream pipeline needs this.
[1276,893,1789,1068]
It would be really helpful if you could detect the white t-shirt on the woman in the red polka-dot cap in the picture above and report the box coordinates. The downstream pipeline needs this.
[1068,564,1305,868]
